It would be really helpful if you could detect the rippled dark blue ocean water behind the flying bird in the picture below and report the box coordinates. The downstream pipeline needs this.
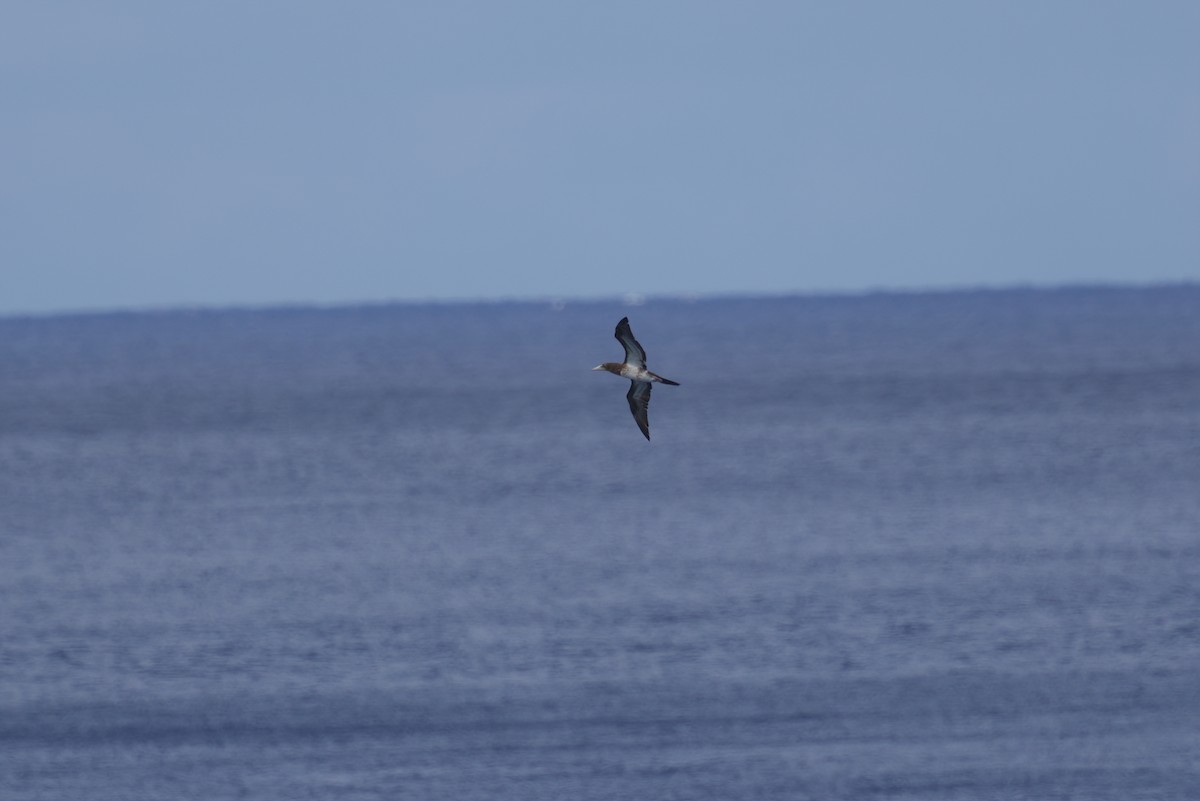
[0,287,1200,801]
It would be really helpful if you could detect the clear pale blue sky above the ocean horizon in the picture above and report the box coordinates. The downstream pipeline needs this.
[0,0,1200,314]
